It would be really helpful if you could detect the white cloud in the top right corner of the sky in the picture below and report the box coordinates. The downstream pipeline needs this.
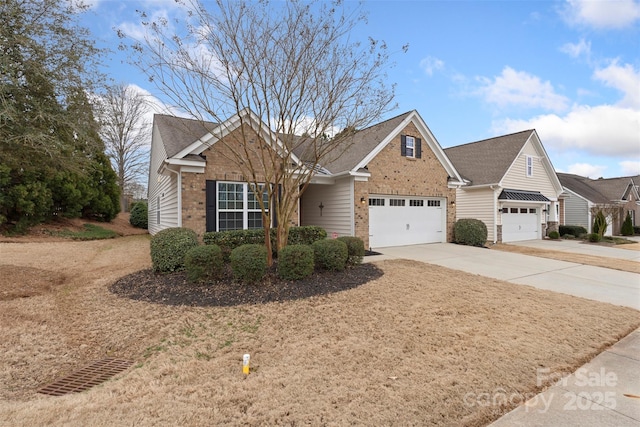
[561,0,640,29]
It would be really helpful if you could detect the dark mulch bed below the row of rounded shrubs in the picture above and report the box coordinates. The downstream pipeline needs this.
[109,263,383,307]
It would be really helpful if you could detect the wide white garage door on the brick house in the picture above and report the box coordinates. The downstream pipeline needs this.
[369,195,446,248]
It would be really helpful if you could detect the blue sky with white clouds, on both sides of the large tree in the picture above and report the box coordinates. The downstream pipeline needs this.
[82,0,640,178]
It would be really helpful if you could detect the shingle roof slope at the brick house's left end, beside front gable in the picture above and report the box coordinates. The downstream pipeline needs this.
[153,114,218,157]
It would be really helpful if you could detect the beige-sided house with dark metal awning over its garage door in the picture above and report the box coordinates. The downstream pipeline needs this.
[444,130,562,242]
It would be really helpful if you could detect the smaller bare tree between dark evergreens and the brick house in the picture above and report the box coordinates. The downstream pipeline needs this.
[99,84,150,210]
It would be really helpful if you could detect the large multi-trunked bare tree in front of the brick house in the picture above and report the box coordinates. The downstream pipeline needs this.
[120,0,406,262]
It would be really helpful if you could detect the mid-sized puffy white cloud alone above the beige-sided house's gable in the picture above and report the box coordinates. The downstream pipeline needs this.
[478,67,568,111]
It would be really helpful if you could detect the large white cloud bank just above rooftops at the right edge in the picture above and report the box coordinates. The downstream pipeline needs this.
[493,105,640,160]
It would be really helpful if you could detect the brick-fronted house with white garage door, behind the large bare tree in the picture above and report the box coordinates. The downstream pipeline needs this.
[149,111,463,248]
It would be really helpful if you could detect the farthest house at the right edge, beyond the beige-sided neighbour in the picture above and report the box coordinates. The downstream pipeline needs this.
[558,173,640,236]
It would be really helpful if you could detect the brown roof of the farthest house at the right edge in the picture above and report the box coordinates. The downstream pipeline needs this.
[558,173,640,203]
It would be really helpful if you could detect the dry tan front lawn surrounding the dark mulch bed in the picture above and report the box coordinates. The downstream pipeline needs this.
[0,231,640,426]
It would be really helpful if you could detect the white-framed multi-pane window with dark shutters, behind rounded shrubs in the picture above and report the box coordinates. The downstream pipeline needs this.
[217,182,269,231]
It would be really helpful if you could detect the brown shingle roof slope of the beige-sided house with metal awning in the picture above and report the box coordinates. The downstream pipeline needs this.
[444,129,534,185]
